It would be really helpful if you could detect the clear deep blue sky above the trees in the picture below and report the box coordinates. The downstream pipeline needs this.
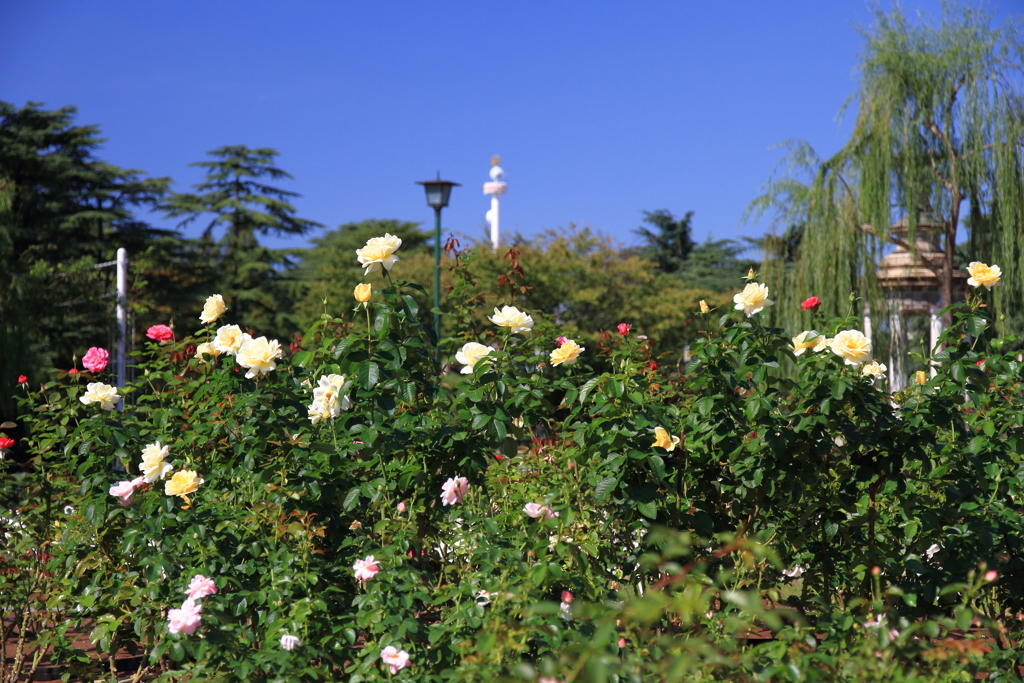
[0,0,1024,246]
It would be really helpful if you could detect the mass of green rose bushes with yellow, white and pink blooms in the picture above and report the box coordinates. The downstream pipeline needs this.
[0,237,1024,683]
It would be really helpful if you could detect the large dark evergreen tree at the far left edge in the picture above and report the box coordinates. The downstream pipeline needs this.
[0,101,171,415]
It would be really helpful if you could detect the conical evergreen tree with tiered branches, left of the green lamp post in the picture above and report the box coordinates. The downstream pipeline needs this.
[162,145,321,339]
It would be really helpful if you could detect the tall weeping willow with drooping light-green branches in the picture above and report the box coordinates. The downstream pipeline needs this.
[748,5,1024,334]
